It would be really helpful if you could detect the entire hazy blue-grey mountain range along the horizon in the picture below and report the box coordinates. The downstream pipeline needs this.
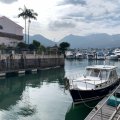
[30,33,120,48]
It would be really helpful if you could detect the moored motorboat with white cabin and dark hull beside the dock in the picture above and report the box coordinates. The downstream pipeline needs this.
[69,65,120,103]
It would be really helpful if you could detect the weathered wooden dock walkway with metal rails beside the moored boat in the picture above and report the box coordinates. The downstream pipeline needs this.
[85,85,120,120]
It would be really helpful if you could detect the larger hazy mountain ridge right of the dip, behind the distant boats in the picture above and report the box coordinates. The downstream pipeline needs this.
[59,33,120,48]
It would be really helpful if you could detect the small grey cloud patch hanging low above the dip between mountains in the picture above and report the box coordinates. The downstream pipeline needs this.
[48,20,76,31]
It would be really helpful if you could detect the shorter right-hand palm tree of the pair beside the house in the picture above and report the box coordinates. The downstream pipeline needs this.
[27,9,38,44]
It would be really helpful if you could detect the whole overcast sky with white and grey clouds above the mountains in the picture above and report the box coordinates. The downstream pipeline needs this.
[0,0,120,41]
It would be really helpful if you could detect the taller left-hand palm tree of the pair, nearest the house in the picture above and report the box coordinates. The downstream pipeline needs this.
[18,6,28,43]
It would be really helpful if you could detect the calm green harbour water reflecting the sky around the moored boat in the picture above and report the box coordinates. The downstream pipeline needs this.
[0,60,120,120]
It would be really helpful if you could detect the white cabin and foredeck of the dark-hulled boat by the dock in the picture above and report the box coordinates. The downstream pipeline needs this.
[72,65,118,90]
